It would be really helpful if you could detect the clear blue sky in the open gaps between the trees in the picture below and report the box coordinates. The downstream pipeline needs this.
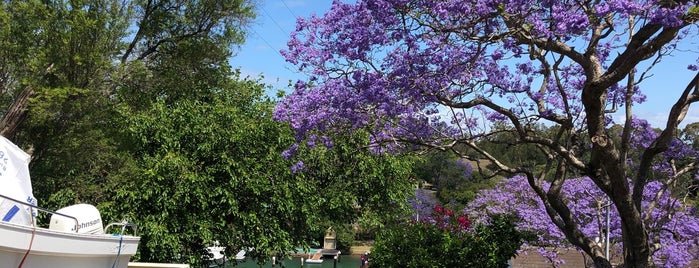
[231,0,699,127]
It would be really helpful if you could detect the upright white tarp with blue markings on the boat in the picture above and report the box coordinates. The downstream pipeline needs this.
[0,136,36,225]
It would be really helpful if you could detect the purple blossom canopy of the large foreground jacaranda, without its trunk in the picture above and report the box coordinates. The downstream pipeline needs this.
[275,0,691,149]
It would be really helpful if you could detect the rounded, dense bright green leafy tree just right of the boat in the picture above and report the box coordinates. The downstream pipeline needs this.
[117,75,314,264]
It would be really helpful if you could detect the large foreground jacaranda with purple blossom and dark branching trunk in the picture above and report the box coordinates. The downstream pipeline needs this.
[276,0,699,267]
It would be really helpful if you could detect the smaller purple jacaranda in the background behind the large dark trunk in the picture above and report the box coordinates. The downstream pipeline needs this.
[465,176,699,267]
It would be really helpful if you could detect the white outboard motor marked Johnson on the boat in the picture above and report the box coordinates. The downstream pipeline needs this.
[49,204,104,234]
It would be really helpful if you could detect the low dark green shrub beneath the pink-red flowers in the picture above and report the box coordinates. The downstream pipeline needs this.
[370,209,526,268]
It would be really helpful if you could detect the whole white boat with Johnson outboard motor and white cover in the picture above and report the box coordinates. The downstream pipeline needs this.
[0,136,140,268]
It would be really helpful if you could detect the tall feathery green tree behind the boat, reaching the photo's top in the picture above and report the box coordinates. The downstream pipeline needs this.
[0,0,254,207]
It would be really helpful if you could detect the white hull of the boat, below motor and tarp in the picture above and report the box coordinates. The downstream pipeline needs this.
[0,222,140,268]
